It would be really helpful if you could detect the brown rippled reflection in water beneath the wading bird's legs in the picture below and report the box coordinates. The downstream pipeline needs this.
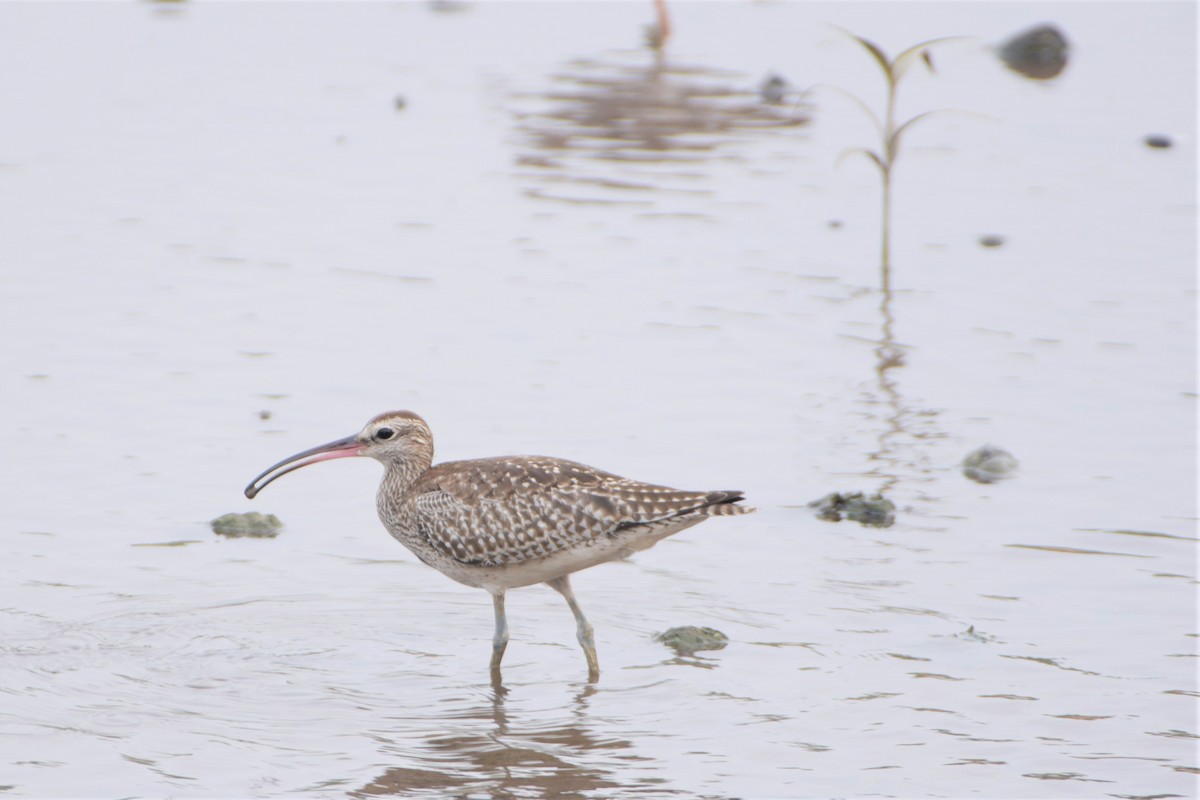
[349,685,662,799]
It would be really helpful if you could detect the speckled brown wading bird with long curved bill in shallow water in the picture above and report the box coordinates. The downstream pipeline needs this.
[245,411,755,682]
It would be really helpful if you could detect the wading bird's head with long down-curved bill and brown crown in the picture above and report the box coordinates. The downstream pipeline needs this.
[246,411,433,498]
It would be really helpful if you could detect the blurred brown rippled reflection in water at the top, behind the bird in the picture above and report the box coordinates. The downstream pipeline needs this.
[516,52,809,203]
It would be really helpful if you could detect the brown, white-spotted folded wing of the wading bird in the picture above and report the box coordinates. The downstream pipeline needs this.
[414,456,740,566]
